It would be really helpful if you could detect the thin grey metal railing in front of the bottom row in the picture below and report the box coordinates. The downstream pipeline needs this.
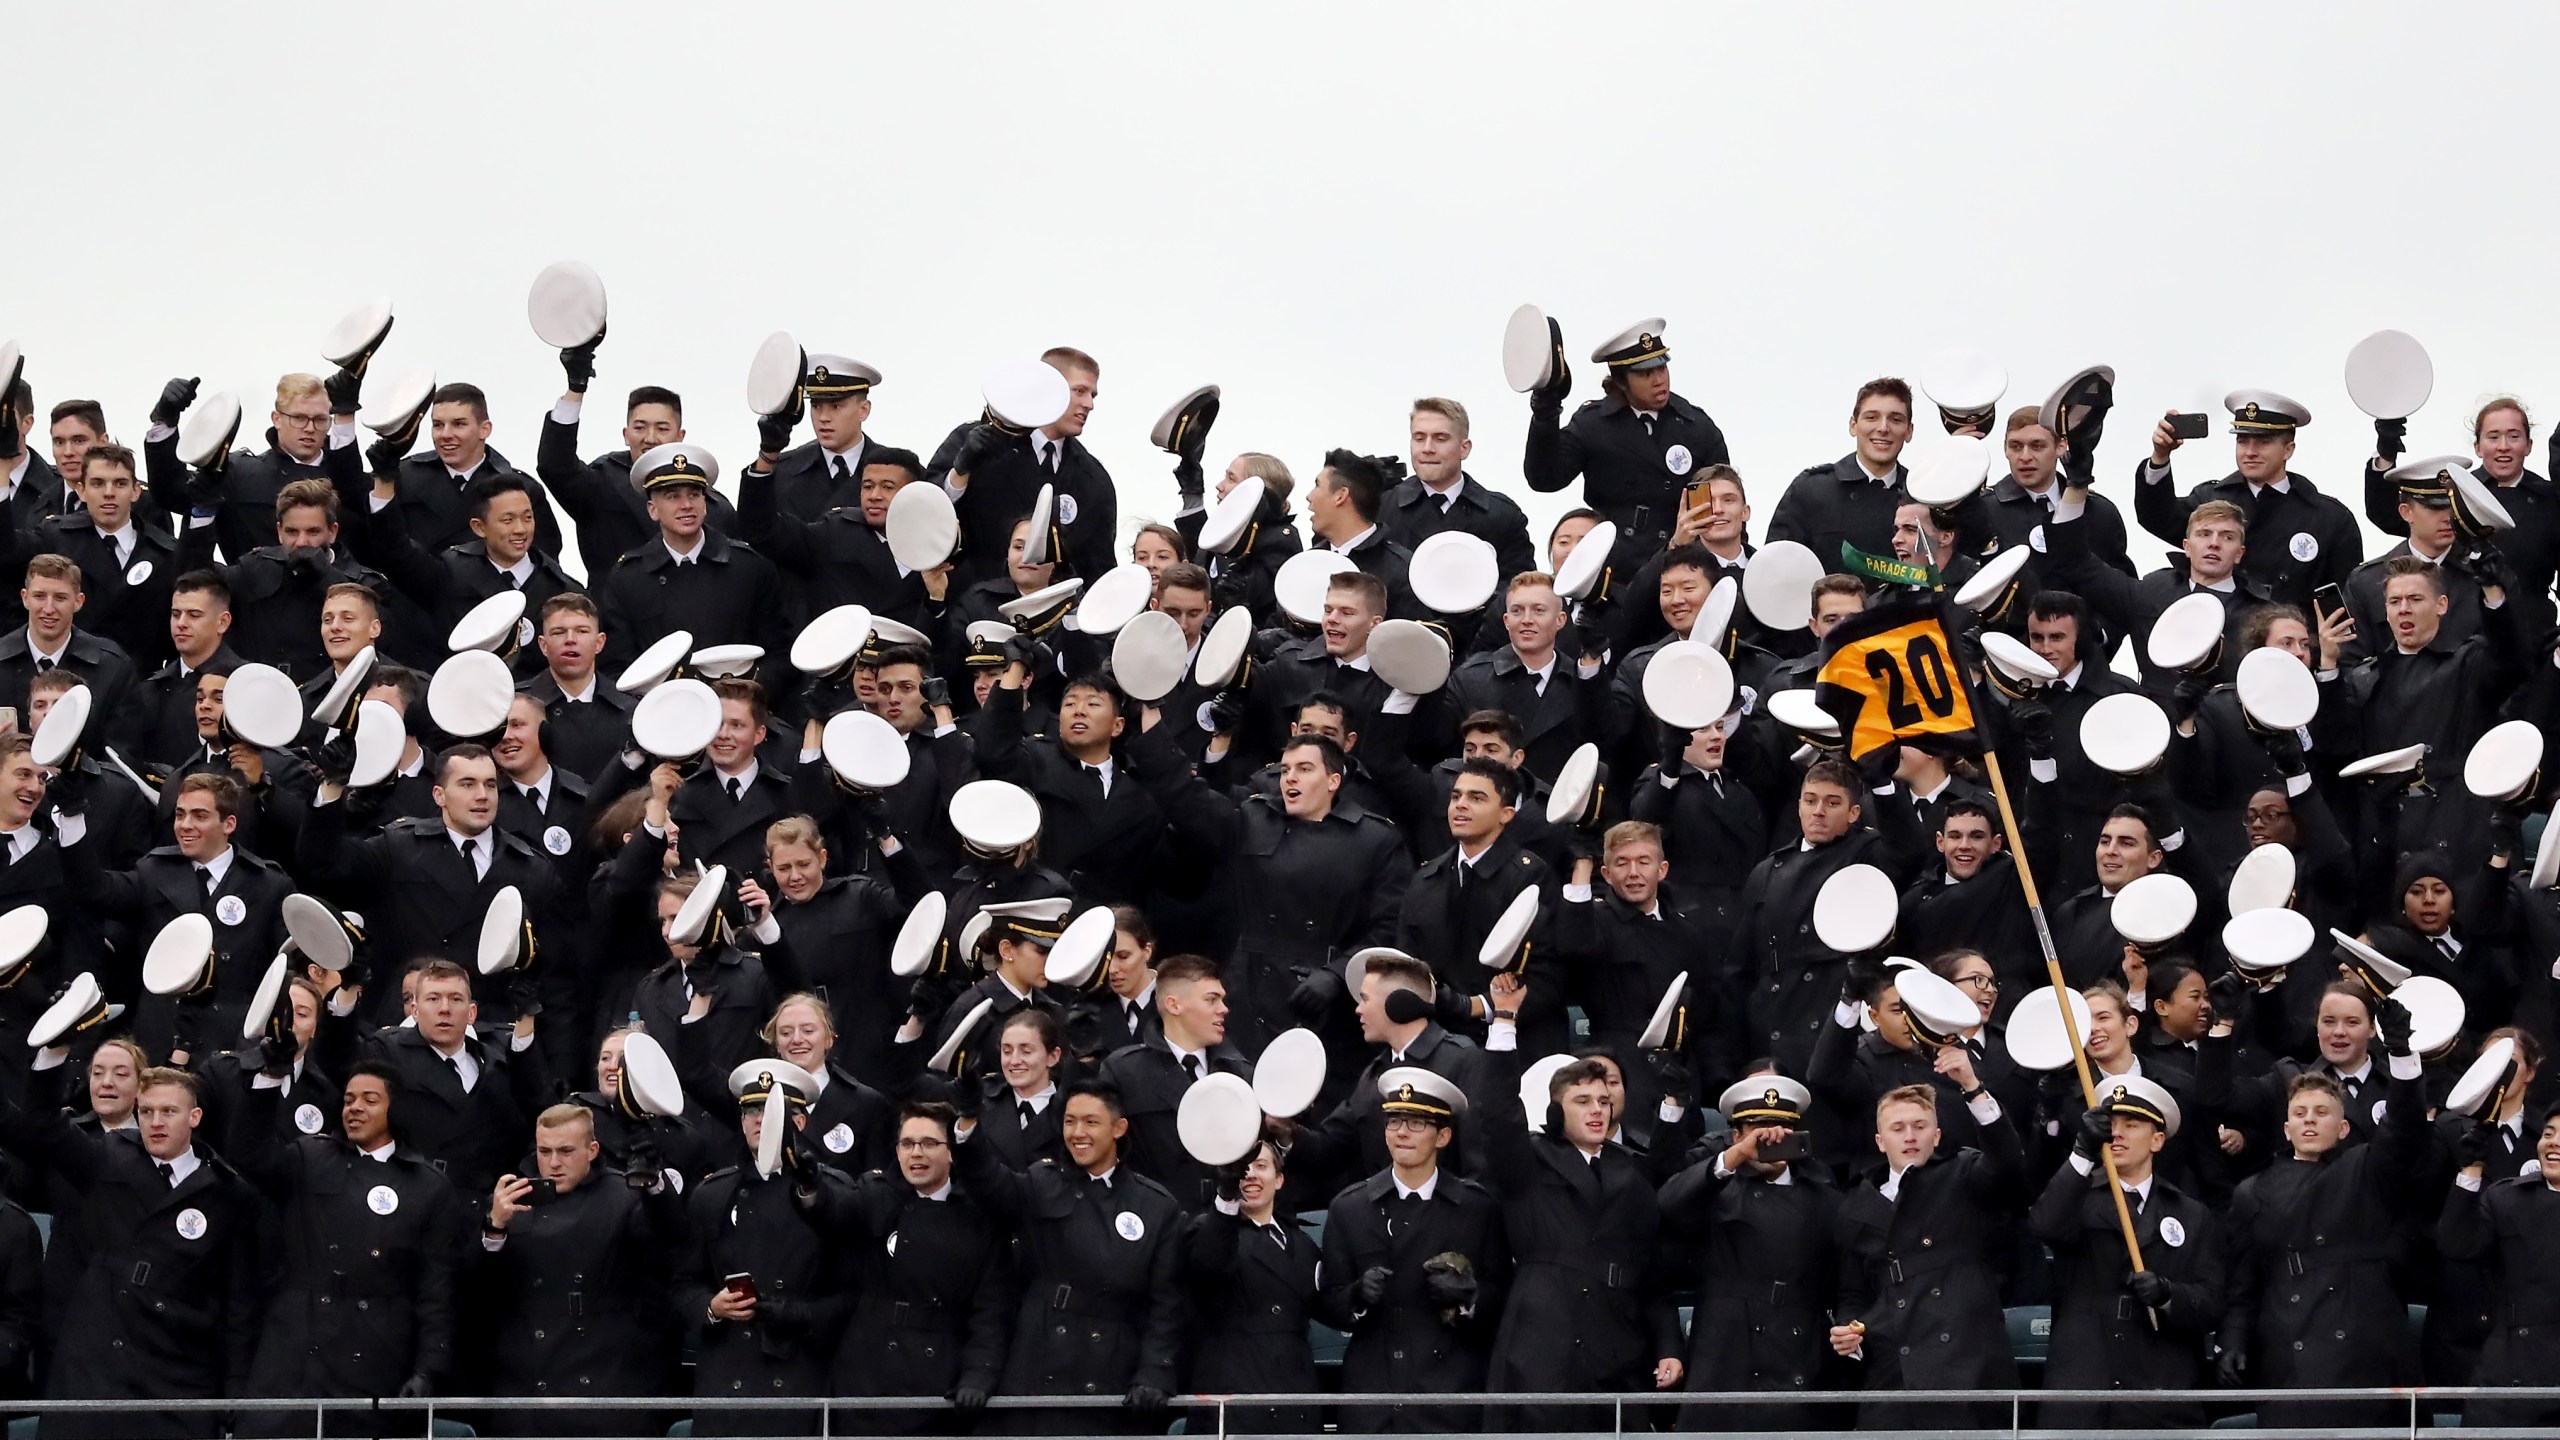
[0,1386,2560,1440]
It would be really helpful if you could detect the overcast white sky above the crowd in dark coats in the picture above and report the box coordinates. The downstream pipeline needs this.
[0,0,2560,579]
